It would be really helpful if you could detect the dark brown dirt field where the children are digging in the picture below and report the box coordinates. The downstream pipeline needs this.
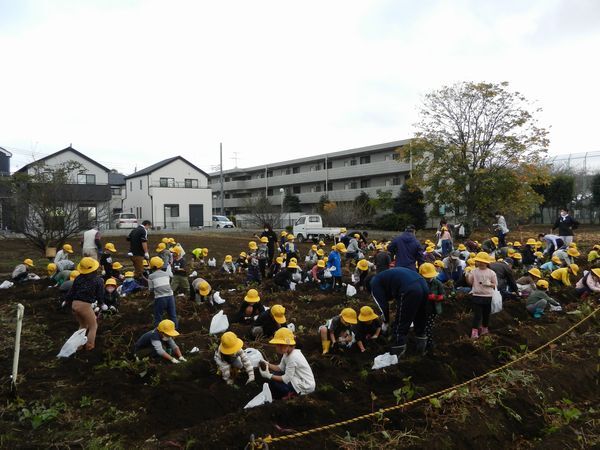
[0,230,600,449]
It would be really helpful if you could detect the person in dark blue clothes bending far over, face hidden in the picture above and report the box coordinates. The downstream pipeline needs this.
[366,267,429,358]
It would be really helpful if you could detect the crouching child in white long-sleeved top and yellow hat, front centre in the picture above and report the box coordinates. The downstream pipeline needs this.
[258,328,316,400]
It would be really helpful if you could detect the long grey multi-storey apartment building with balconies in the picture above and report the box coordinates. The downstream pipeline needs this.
[209,139,410,215]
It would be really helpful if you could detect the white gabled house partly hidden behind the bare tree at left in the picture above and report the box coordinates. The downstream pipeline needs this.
[17,146,111,228]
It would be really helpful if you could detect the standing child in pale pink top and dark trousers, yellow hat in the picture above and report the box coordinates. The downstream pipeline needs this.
[467,252,498,339]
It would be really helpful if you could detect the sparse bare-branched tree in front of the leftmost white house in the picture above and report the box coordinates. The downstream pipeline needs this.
[10,161,110,252]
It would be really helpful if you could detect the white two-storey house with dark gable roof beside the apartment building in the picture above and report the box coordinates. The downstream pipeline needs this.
[123,156,212,229]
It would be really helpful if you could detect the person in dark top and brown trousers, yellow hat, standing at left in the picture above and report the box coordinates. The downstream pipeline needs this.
[65,256,104,350]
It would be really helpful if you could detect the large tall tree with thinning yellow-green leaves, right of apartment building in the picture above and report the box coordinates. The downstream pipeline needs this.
[400,82,549,226]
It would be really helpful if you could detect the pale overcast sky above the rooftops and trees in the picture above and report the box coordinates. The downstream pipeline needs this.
[0,0,600,173]
